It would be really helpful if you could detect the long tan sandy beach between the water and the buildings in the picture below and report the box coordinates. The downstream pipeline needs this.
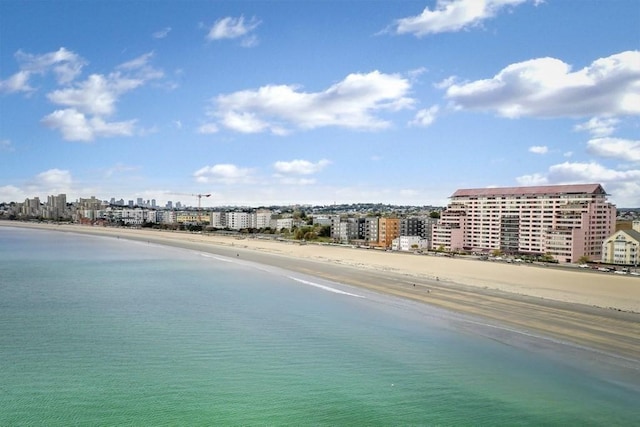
[0,222,640,362]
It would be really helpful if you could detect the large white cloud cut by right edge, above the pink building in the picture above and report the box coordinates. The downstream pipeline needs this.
[446,51,640,118]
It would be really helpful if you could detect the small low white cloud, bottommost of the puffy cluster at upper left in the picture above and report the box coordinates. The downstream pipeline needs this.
[42,108,135,142]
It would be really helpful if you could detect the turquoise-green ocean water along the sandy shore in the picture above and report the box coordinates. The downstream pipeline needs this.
[0,227,640,426]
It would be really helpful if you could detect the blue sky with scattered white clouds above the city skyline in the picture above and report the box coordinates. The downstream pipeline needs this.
[0,0,640,207]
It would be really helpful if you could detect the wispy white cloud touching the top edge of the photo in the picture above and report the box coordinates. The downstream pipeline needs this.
[391,0,527,37]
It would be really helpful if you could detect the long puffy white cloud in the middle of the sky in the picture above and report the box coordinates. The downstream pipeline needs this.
[209,71,414,135]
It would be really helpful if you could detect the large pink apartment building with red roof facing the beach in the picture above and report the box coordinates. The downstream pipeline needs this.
[432,184,616,263]
